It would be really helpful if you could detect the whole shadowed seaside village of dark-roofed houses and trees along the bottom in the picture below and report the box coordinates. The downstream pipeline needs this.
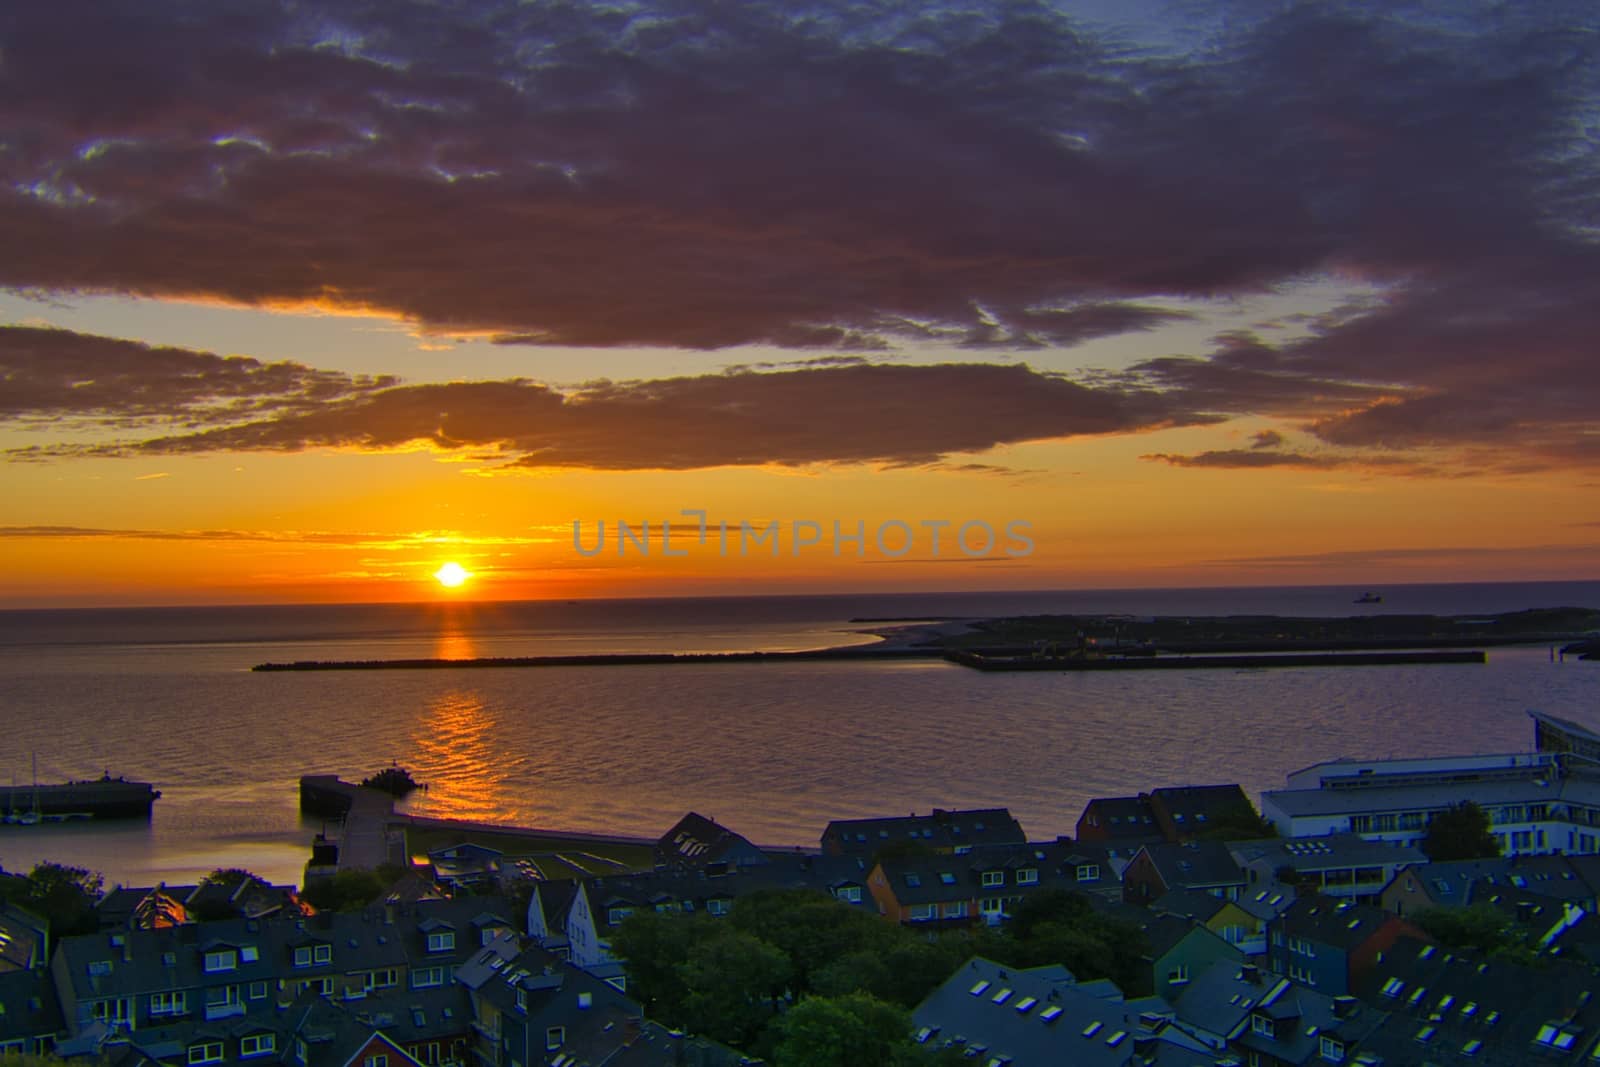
[0,712,1600,1067]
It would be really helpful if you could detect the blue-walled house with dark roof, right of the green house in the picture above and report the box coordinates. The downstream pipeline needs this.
[1267,896,1426,995]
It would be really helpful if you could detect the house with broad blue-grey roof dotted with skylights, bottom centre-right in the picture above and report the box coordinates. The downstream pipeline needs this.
[912,957,1224,1067]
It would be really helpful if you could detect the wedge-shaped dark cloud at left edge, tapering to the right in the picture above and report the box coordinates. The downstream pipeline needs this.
[0,326,395,426]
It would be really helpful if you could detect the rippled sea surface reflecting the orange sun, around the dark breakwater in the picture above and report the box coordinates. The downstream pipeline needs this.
[0,582,1600,885]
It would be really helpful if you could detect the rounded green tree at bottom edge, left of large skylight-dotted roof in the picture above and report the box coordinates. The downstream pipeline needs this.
[771,993,920,1067]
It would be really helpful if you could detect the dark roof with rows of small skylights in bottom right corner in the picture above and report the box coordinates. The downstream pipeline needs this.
[1357,937,1600,1067]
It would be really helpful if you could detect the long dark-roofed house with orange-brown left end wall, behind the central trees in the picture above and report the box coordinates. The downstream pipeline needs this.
[867,840,1115,925]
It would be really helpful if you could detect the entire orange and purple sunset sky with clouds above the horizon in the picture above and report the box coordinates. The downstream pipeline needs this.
[0,0,1600,606]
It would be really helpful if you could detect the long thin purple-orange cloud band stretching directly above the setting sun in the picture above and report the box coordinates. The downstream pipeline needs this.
[13,356,1205,470]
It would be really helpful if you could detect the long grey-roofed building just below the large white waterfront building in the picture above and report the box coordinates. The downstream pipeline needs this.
[1229,833,1427,904]
